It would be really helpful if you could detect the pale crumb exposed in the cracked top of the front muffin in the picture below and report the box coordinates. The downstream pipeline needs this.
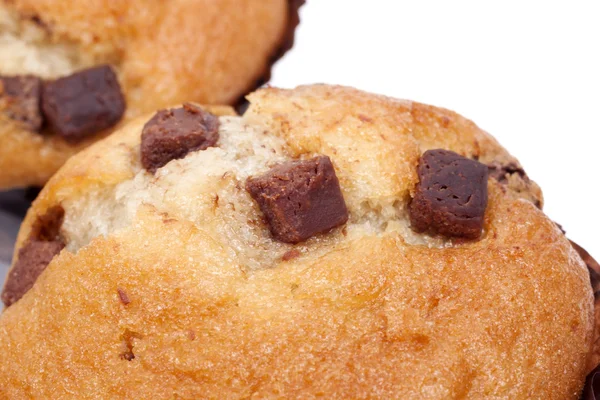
[62,116,449,269]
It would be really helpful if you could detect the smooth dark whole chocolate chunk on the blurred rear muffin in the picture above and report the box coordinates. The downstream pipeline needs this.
[42,65,125,143]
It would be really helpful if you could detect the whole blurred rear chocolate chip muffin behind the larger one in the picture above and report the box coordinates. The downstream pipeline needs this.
[0,0,303,190]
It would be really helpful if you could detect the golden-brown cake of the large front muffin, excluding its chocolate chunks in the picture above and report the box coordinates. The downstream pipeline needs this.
[0,86,593,400]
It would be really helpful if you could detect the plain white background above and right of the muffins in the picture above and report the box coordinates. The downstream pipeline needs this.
[271,0,600,259]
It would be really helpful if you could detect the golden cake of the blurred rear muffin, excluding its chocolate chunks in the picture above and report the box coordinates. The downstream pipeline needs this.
[0,0,298,189]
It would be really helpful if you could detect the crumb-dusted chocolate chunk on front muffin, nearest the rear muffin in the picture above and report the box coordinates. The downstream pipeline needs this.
[141,104,219,173]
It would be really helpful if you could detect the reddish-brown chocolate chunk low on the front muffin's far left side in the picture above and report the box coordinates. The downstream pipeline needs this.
[2,239,65,307]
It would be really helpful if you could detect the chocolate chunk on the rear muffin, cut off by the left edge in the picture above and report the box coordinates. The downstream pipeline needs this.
[0,75,43,132]
